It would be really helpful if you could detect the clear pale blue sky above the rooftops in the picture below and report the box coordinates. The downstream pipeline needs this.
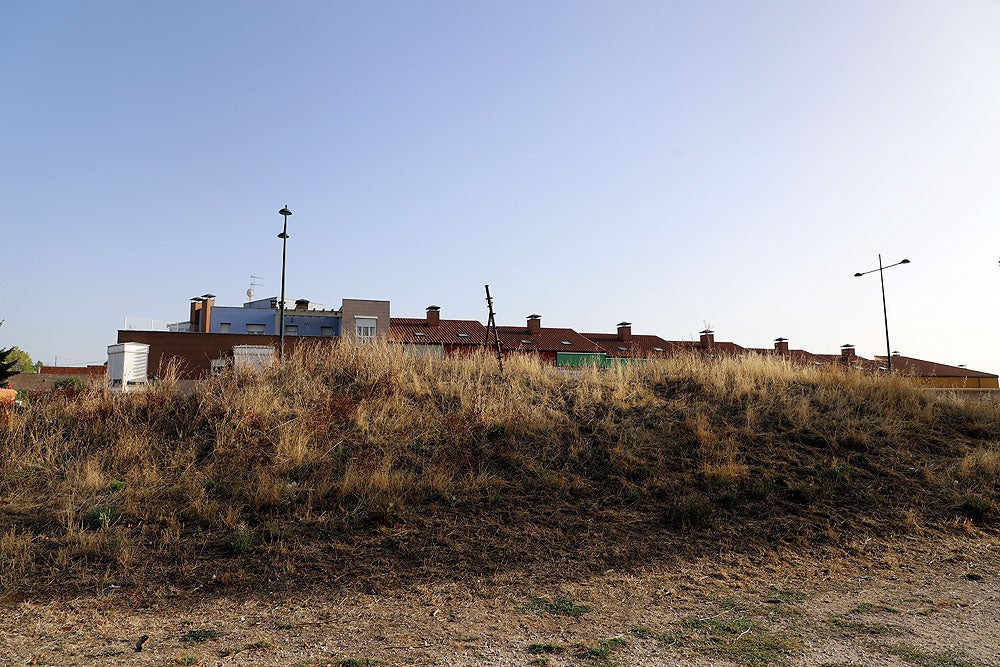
[0,0,1000,372]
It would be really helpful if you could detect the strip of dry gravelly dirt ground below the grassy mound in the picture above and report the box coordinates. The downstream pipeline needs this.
[0,538,1000,667]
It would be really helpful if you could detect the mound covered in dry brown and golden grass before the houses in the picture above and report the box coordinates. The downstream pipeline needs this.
[0,344,1000,598]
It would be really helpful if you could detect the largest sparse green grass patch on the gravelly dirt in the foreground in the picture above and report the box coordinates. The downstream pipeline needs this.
[677,614,795,667]
